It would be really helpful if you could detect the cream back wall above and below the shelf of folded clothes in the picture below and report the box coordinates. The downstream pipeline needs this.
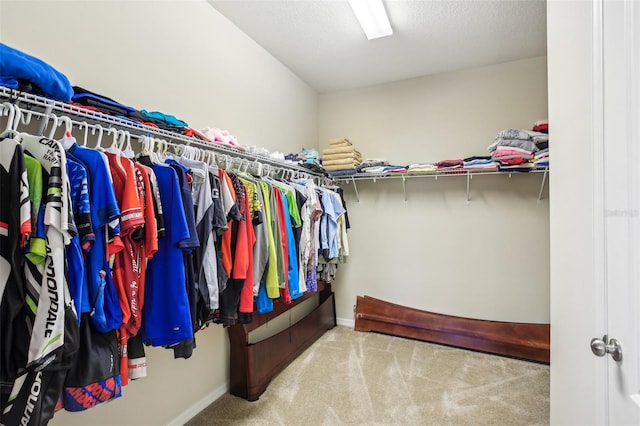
[319,57,553,323]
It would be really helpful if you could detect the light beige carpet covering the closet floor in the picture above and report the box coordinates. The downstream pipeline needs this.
[187,327,549,426]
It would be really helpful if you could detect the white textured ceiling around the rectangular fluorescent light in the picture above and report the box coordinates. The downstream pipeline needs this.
[208,0,547,93]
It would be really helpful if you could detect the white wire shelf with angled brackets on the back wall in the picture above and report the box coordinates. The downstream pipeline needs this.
[333,167,549,204]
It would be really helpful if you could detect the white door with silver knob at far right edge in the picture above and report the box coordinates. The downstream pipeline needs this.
[592,0,640,425]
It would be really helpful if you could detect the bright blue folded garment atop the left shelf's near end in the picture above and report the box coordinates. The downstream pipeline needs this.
[0,43,73,102]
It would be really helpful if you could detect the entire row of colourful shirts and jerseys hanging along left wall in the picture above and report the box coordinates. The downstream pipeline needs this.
[0,109,348,425]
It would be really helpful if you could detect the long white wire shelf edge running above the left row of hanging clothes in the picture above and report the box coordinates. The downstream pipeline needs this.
[0,87,323,178]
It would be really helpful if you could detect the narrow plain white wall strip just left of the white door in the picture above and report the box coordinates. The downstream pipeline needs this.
[547,1,606,425]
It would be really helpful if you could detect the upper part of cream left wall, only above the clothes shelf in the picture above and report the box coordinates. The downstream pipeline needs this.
[0,0,317,153]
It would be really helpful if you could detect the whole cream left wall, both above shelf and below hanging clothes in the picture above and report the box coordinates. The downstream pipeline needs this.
[0,0,318,425]
